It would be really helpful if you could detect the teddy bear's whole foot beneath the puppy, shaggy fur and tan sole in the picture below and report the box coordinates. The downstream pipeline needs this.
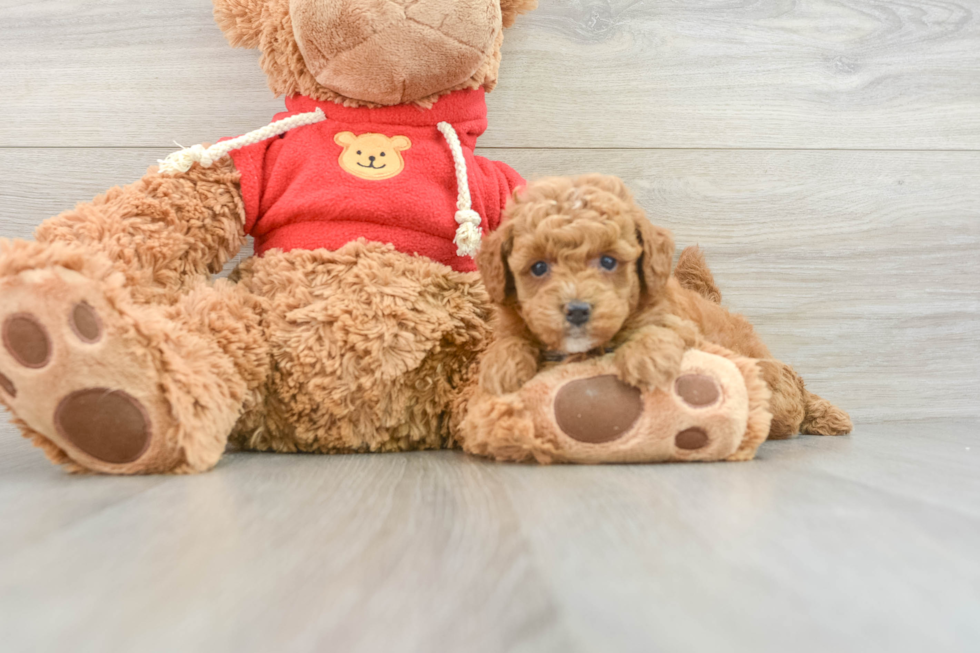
[463,350,769,463]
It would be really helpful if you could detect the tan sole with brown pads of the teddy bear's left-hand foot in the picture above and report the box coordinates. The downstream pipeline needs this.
[0,267,178,474]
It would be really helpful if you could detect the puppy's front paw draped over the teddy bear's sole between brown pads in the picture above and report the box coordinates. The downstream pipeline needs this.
[615,328,684,390]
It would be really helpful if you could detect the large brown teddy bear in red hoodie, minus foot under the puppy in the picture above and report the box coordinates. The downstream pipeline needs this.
[0,0,535,474]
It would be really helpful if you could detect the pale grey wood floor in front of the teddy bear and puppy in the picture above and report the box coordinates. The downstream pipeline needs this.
[0,423,980,653]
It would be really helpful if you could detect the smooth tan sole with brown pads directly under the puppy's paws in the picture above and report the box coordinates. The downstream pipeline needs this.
[537,350,749,462]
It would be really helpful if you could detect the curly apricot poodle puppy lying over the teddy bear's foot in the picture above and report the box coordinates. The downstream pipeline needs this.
[478,175,851,438]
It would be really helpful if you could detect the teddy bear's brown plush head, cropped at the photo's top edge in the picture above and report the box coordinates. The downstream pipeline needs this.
[213,0,537,106]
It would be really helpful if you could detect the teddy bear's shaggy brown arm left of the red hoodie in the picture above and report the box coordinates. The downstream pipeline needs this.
[35,157,245,301]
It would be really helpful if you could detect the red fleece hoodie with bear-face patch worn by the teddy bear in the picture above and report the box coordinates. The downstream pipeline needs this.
[231,90,524,271]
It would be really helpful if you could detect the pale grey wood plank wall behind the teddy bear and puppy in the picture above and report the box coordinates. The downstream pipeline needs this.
[0,0,980,423]
